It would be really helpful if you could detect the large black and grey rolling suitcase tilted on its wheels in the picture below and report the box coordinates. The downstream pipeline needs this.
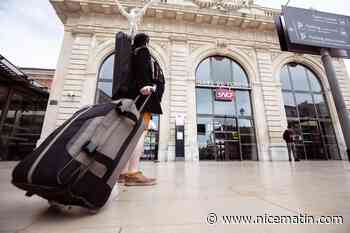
[12,97,149,210]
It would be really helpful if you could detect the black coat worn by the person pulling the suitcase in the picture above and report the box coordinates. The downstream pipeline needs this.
[131,47,163,114]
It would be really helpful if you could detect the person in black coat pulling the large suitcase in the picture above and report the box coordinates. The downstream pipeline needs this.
[118,33,164,186]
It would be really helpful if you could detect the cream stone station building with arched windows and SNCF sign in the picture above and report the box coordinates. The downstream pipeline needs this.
[41,0,350,161]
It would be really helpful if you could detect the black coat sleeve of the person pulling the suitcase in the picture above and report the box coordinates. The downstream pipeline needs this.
[134,47,153,90]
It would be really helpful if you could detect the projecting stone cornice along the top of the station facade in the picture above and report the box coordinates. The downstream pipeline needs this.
[50,0,280,31]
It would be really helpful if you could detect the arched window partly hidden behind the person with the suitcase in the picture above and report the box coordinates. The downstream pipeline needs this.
[95,54,159,160]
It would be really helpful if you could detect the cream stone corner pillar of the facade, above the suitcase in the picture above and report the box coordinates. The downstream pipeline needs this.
[38,31,93,145]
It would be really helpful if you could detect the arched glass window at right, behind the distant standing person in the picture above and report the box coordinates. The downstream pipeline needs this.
[280,63,340,160]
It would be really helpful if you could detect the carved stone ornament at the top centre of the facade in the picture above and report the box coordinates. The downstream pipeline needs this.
[192,0,254,11]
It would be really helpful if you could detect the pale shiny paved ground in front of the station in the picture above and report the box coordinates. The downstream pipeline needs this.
[0,161,350,233]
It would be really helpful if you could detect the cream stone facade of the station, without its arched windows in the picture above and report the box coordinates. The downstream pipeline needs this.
[42,0,350,161]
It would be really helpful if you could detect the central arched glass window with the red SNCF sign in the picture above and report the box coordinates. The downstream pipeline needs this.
[196,56,258,160]
